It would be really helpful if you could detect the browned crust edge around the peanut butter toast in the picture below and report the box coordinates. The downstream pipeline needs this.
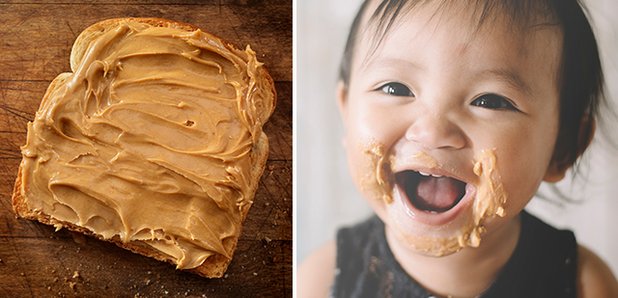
[12,18,276,278]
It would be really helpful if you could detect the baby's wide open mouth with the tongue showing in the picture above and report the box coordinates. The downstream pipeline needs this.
[395,170,466,213]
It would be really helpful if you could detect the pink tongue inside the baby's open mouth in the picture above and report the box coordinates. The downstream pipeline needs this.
[416,177,465,212]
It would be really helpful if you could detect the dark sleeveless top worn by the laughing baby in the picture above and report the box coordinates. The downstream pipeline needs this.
[331,211,577,298]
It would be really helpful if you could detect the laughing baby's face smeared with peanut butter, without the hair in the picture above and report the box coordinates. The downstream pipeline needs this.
[340,5,562,255]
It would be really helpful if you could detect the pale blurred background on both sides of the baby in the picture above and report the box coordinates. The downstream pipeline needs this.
[295,0,618,275]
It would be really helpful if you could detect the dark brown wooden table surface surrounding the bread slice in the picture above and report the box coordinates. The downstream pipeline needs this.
[0,0,292,297]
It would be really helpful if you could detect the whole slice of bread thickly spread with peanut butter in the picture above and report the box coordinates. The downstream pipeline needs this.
[12,18,276,277]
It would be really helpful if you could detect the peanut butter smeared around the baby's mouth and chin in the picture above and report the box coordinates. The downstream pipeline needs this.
[362,143,507,257]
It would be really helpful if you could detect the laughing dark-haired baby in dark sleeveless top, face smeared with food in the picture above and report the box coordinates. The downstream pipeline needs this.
[298,0,618,297]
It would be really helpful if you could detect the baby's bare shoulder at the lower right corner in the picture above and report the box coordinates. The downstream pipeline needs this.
[577,245,618,297]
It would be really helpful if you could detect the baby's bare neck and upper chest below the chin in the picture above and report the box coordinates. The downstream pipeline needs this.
[386,216,521,297]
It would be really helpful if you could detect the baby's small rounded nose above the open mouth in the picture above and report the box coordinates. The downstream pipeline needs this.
[405,113,466,149]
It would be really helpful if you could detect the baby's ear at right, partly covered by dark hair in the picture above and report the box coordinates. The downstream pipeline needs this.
[543,114,596,183]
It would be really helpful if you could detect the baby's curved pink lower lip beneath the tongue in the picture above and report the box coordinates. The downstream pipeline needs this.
[395,183,476,226]
